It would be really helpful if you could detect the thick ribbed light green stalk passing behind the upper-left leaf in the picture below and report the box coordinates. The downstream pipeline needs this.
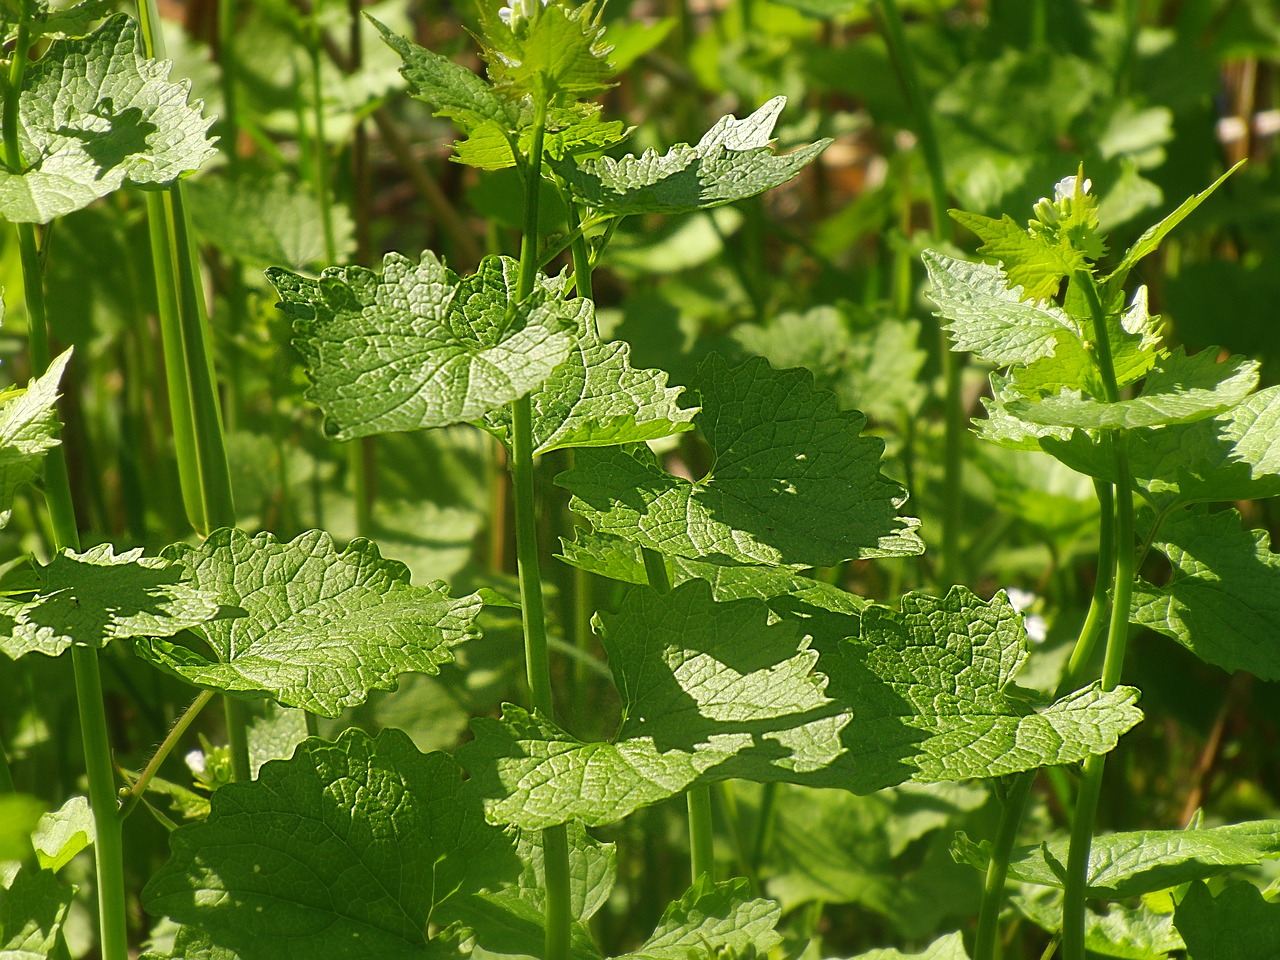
[138,0,251,780]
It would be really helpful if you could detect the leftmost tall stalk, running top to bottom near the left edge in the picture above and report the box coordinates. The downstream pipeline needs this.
[3,11,129,960]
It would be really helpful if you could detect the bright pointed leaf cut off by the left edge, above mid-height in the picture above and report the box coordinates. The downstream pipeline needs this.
[0,349,72,527]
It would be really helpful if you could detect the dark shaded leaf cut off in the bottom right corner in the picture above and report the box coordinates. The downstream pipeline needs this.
[1174,883,1280,960]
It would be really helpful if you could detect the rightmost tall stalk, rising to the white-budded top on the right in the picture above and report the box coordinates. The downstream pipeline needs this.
[1062,270,1134,960]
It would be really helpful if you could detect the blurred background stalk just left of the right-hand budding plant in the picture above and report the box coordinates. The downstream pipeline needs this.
[878,0,966,585]
